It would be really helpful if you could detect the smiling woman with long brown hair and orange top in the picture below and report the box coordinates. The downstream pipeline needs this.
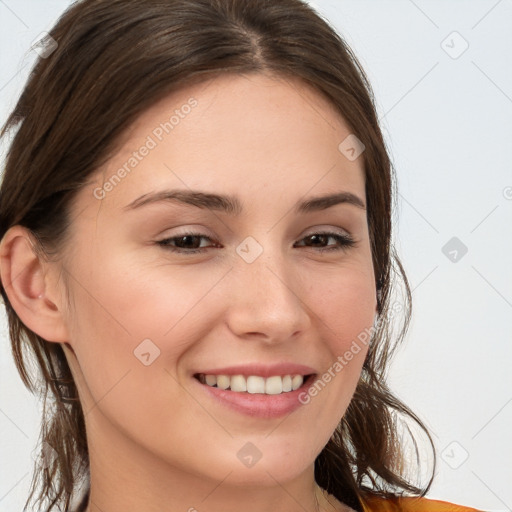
[0,0,480,512]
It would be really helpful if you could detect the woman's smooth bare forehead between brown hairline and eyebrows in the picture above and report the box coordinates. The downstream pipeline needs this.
[78,73,364,218]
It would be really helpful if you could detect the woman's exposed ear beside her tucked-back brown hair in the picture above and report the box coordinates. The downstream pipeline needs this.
[0,225,69,342]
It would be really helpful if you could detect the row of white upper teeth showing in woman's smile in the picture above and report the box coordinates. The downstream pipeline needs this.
[199,374,304,395]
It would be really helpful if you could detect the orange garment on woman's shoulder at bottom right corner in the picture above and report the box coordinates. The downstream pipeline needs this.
[363,497,479,512]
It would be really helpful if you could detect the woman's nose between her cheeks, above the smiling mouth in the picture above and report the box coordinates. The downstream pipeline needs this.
[227,243,311,344]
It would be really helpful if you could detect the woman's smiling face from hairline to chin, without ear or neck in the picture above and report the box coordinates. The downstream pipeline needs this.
[58,74,376,484]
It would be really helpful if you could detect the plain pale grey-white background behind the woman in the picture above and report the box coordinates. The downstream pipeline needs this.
[0,0,512,512]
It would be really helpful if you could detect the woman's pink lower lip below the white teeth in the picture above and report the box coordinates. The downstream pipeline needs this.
[192,375,315,418]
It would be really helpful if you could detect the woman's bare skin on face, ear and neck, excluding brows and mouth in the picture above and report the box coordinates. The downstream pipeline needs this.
[0,74,377,512]
